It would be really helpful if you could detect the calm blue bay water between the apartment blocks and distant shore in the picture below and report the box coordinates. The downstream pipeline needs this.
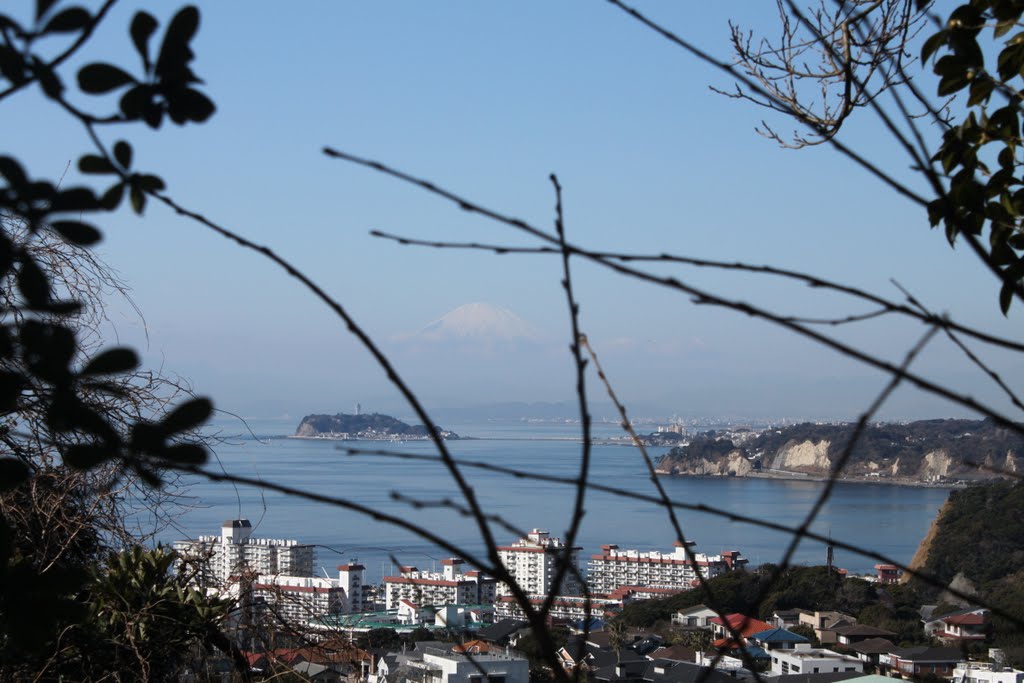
[161,421,948,581]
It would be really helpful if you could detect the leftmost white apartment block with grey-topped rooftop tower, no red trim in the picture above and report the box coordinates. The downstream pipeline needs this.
[173,519,315,588]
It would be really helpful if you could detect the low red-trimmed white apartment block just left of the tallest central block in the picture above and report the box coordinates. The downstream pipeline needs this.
[384,557,496,609]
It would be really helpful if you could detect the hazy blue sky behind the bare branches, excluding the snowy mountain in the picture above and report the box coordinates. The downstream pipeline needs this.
[0,0,1022,419]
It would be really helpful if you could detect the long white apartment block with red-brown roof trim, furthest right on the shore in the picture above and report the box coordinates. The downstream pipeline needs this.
[587,542,748,594]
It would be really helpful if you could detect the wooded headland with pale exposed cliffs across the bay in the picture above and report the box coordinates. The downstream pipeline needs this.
[657,420,1024,483]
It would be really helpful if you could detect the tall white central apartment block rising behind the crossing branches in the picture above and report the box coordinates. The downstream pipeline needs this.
[498,528,583,599]
